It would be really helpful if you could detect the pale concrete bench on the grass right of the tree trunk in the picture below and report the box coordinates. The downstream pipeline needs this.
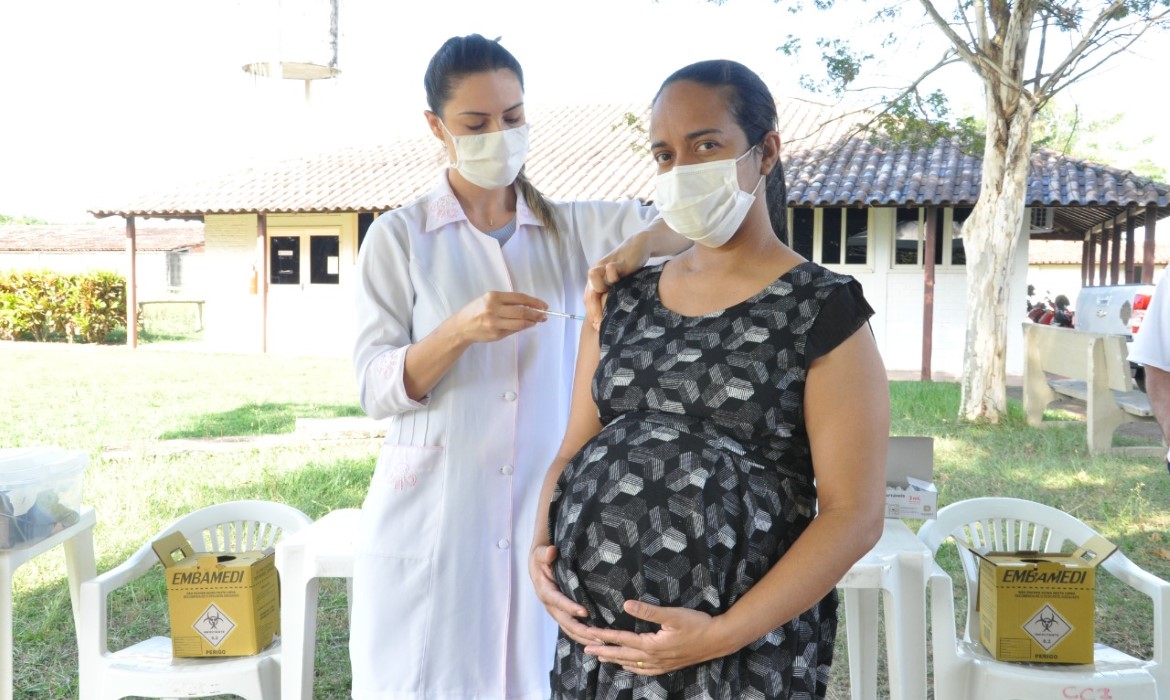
[1024,322,1162,453]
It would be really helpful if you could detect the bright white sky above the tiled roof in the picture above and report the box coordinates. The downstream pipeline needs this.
[0,0,1170,222]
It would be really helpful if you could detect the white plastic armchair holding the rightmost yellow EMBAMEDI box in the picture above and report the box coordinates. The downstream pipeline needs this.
[918,497,1170,700]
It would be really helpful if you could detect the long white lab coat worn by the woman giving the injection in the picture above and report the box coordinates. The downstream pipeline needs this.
[350,177,654,700]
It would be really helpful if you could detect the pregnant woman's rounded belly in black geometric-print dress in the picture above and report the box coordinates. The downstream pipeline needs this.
[550,420,812,632]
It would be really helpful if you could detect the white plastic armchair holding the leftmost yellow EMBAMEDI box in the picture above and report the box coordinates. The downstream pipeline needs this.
[77,501,312,700]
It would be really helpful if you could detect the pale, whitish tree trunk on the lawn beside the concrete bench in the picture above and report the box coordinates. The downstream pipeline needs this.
[959,101,1033,423]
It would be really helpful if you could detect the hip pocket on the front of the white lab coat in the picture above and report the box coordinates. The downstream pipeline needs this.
[362,445,447,558]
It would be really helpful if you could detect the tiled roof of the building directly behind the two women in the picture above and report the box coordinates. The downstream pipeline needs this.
[92,98,1170,218]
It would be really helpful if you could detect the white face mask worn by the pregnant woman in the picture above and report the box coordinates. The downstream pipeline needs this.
[654,146,764,248]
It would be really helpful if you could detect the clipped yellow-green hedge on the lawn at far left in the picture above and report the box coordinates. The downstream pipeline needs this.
[0,270,126,343]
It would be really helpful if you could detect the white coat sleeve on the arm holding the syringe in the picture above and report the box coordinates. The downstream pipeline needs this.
[353,214,427,419]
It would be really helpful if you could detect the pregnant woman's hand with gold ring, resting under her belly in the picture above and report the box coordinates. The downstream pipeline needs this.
[585,601,738,675]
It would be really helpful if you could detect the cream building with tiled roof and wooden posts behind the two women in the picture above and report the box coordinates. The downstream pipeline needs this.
[91,98,1170,373]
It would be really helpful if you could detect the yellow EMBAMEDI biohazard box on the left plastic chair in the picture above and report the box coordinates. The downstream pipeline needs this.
[152,533,281,657]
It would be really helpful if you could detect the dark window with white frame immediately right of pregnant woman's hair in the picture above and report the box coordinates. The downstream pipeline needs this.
[789,207,869,266]
